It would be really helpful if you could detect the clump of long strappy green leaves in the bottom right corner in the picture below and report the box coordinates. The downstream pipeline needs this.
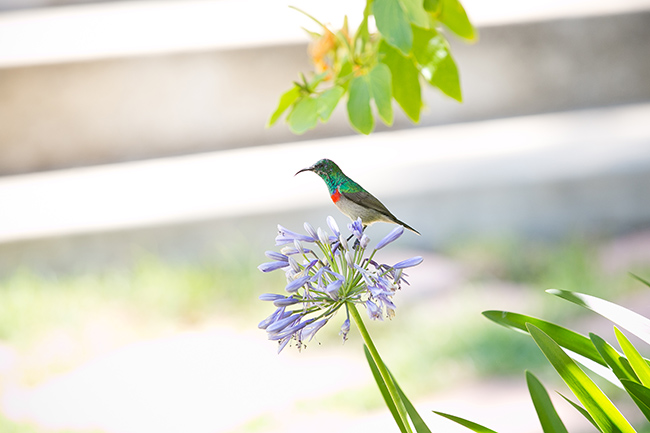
[436,276,650,433]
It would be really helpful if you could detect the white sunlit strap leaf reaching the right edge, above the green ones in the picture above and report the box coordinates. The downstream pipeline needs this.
[546,289,650,344]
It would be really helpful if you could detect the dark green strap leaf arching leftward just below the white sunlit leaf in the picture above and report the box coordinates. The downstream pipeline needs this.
[483,310,607,366]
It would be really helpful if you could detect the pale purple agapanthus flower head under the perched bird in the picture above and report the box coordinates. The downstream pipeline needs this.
[258,217,422,352]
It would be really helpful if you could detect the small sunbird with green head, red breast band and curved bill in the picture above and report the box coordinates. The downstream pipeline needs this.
[294,159,420,235]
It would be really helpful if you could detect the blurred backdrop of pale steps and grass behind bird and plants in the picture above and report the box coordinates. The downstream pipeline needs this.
[0,0,650,433]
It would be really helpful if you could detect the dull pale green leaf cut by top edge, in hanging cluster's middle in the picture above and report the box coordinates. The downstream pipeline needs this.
[372,0,413,55]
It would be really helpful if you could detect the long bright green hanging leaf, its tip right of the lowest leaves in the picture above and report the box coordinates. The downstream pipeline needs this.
[379,42,422,123]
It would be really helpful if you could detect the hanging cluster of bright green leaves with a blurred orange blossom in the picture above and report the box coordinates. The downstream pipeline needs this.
[267,0,477,134]
